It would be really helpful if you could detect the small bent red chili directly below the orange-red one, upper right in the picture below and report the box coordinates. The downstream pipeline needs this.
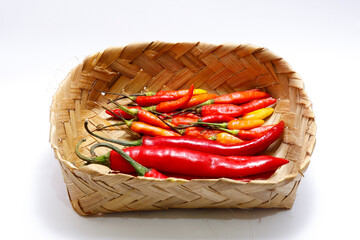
[197,97,276,117]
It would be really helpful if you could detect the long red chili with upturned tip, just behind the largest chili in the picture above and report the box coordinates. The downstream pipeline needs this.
[84,121,284,156]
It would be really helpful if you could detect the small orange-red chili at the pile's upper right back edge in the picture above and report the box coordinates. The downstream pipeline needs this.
[214,89,270,104]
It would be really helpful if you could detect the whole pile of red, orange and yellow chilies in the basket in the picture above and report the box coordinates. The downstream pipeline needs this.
[76,85,288,181]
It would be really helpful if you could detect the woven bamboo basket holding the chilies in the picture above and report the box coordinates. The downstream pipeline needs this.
[50,41,316,215]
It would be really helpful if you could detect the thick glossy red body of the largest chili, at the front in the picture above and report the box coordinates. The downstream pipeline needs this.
[88,143,289,178]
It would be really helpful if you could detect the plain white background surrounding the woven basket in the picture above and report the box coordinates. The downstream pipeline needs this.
[0,0,360,239]
